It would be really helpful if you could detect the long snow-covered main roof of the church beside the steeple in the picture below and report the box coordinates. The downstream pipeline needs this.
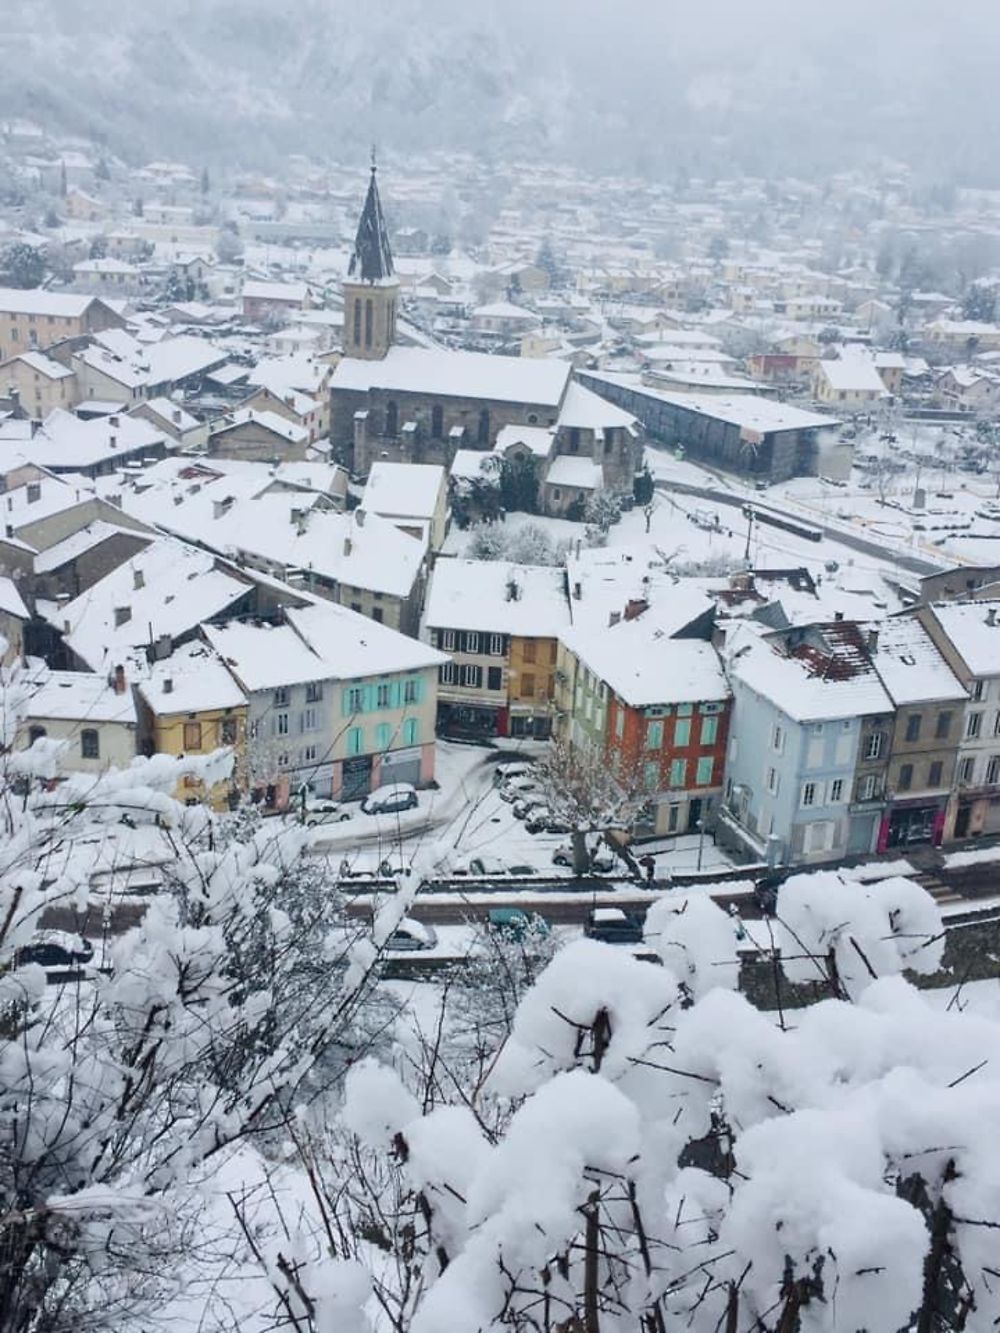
[332,347,571,408]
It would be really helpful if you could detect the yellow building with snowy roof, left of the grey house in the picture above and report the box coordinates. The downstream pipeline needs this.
[139,643,247,809]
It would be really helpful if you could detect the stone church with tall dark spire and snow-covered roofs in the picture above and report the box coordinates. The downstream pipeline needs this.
[331,165,643,515]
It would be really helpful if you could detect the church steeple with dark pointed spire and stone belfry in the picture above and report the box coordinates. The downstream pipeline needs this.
[343,151,399,361]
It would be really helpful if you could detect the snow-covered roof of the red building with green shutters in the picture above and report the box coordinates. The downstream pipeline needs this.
[560,612,729,708]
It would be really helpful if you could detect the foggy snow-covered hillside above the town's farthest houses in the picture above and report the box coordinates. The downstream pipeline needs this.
[0,0,1000,184]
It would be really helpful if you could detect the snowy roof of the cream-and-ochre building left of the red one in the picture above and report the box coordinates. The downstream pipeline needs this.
[424,560,569,639]
